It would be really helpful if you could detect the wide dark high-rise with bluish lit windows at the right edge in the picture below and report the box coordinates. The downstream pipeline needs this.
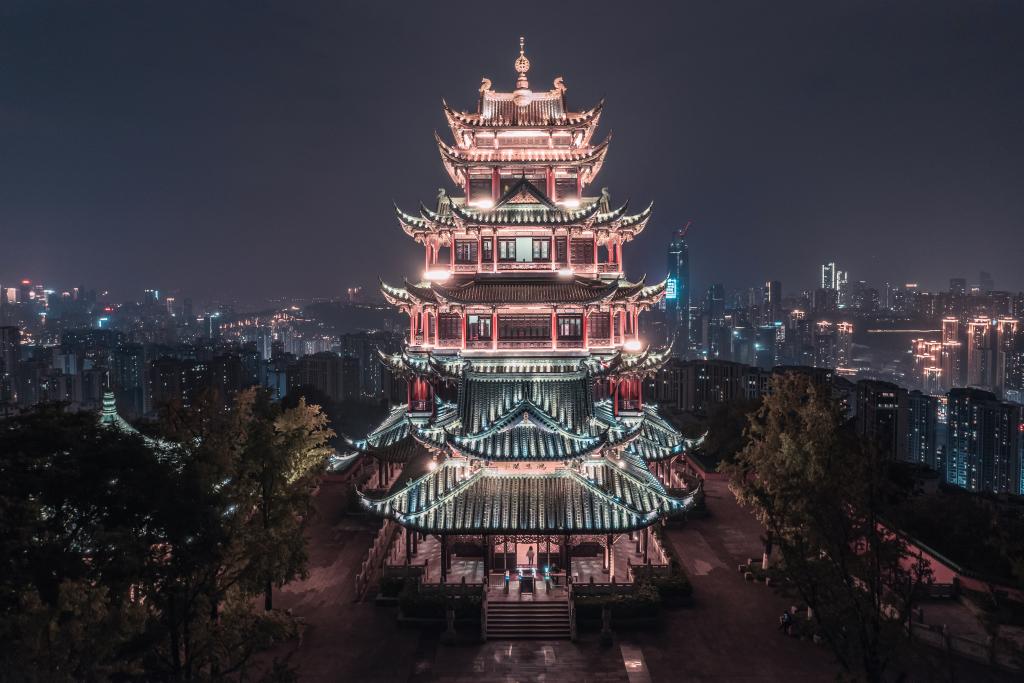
[945,388,1022,495]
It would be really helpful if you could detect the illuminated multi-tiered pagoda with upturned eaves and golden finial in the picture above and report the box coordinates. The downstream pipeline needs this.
[349,39,698,582]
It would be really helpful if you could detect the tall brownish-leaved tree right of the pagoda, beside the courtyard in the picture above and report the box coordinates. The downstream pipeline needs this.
[726,374,930,681]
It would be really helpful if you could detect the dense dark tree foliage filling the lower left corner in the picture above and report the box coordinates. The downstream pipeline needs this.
[0,390,331,681]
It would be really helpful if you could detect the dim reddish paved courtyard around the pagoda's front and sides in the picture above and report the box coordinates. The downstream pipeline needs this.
[273,481,1010,683]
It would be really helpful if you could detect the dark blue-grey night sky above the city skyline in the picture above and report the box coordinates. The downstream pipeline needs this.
[0,0,1024,300]
